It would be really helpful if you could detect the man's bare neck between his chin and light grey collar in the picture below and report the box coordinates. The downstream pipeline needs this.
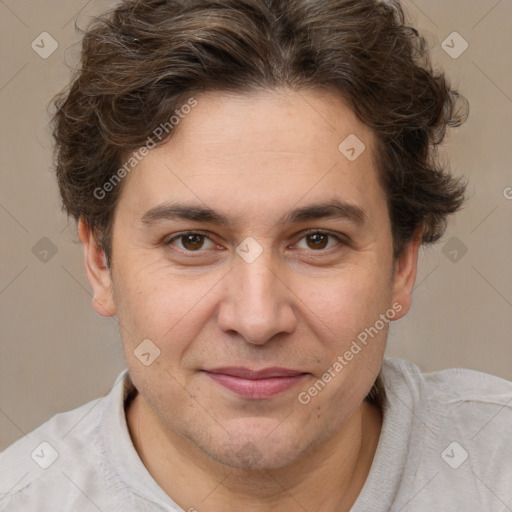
[126,394,382,512]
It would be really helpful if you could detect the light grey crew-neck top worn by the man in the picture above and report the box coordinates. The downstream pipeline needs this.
[0,358,512,512]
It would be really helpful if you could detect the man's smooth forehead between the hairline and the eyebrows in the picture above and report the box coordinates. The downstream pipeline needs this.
[115,89,383,224]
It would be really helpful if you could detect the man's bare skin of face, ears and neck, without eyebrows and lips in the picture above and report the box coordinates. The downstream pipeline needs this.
[79,89,419,512]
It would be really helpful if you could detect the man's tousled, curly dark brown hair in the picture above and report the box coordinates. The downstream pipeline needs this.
[52,0,469,265]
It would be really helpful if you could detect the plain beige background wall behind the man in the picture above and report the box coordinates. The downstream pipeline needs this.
[0,0,512,450]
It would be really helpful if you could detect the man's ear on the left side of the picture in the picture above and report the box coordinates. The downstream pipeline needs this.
[78,218,116,317]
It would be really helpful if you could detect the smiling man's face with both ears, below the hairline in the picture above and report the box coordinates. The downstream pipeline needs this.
[80,89,417,468]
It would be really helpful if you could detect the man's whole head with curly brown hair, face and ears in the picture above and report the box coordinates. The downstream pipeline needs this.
[54,0,466,467]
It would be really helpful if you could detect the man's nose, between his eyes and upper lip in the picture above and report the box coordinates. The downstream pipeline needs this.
[218,249,297,345]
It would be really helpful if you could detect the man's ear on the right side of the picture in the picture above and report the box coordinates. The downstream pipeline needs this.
[393,230,422,320]
